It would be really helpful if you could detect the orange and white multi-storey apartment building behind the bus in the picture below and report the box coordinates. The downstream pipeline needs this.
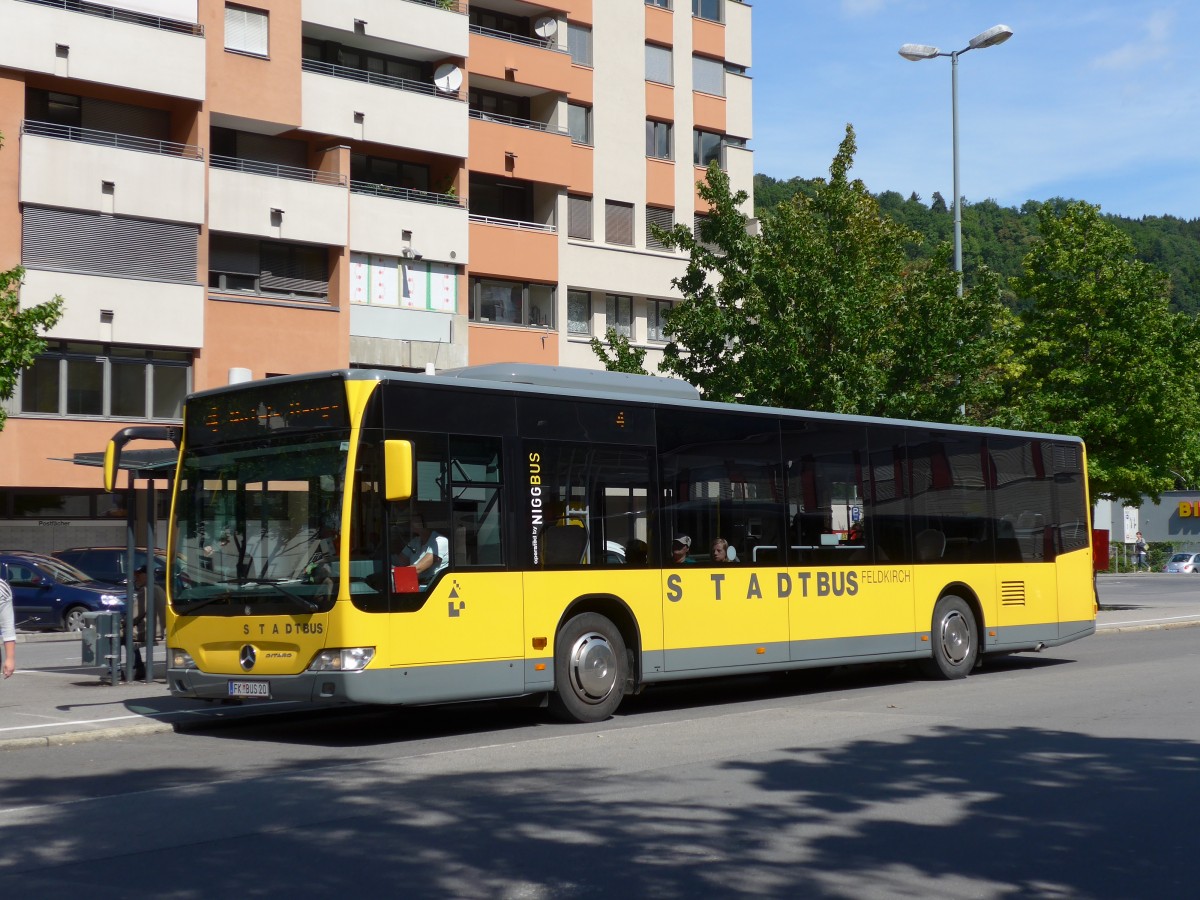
[0,0,754,550]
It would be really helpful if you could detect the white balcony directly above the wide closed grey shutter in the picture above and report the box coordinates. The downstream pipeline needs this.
[19,121,204,224]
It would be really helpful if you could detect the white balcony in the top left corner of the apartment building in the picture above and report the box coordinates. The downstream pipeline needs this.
[0,0,205,100]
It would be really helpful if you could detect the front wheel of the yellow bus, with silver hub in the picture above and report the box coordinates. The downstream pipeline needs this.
[550,612,628,722]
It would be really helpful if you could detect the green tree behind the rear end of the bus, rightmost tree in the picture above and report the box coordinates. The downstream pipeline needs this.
[1012,202,1200,504]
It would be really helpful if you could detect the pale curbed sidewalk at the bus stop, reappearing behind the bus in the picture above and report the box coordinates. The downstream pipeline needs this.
[0,607,1200,751]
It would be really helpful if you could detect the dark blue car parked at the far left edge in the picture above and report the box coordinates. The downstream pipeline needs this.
[0,551,125,631]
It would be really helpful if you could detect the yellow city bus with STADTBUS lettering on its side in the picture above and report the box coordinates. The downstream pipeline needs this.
[109,365,1097,721]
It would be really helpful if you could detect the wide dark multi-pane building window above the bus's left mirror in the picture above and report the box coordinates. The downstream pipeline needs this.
[18,341,192,419]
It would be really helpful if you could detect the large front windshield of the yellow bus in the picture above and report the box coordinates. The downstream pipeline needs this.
[173,430,349,614]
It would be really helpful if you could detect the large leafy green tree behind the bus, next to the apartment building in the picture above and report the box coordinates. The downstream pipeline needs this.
[661,126,1013,420]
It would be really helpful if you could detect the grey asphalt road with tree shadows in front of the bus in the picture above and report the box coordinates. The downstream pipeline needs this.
[0,595,1200,899]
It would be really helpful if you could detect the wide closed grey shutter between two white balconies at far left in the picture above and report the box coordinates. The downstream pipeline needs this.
[20,206,199,284]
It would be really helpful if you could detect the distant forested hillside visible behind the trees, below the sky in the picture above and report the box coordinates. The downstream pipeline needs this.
[754,175,1200,314]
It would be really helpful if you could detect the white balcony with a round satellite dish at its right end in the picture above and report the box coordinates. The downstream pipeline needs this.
[301,60,467,158]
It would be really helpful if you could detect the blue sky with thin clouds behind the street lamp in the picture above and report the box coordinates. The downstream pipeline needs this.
[750,0,1200,218]
